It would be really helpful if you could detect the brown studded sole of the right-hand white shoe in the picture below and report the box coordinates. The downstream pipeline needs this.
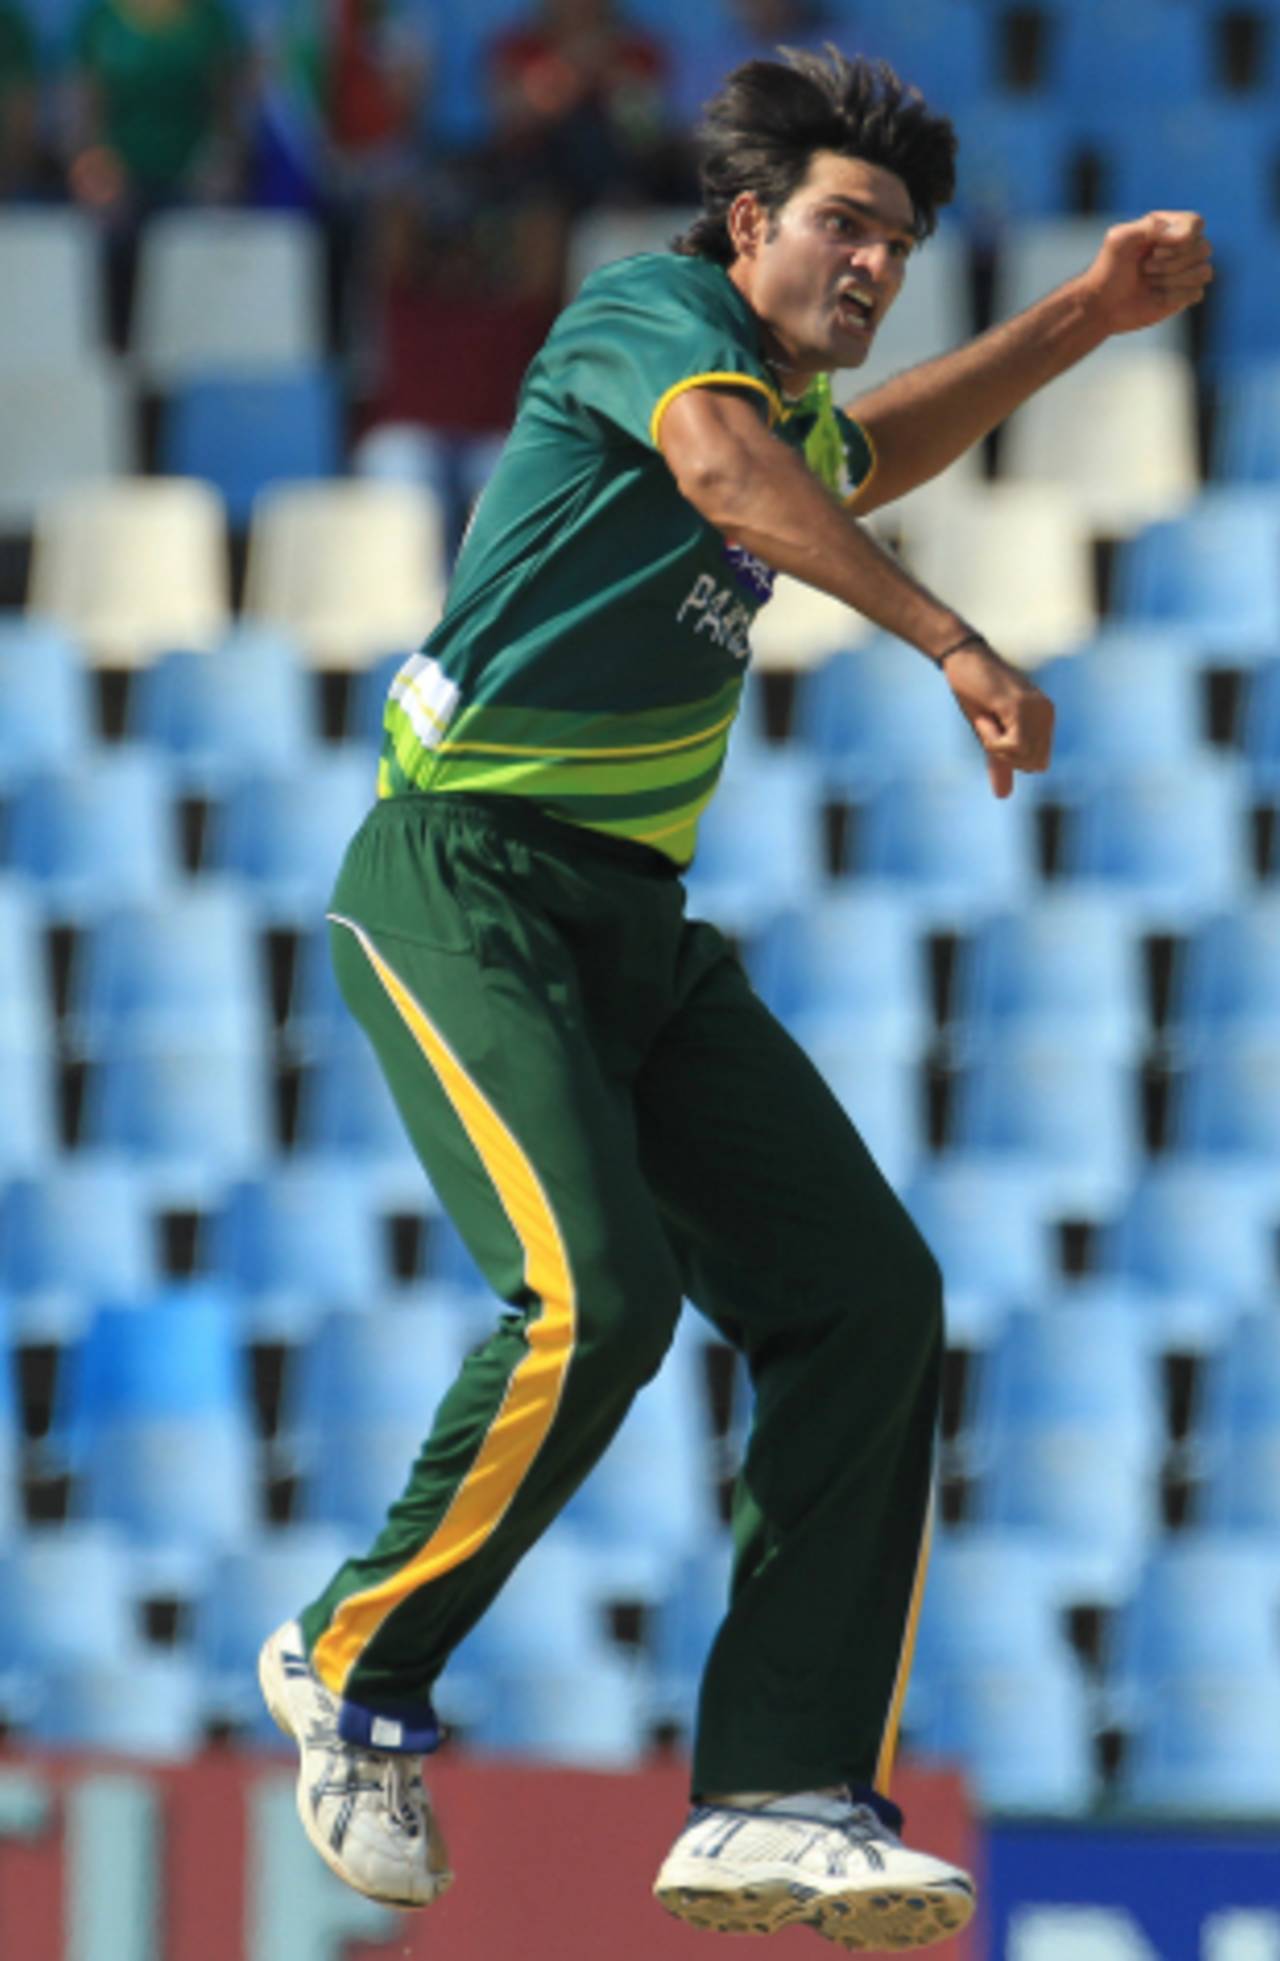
[653,1879,976,1953]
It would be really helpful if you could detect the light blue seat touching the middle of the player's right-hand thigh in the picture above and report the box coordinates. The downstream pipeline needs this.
[747,890,933,1057]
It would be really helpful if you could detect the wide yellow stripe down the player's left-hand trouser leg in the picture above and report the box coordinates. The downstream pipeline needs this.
[312,914,576,1694]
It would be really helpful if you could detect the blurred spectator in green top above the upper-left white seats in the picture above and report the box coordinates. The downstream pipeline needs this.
[67,0,247,343]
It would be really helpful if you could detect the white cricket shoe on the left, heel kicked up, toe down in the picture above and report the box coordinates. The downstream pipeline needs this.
[259,1620,453,1906]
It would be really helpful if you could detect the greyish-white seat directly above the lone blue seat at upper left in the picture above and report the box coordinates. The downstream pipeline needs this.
[131,210,323,388]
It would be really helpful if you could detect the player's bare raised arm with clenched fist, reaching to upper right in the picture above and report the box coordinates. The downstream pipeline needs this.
[849,212,1213,518]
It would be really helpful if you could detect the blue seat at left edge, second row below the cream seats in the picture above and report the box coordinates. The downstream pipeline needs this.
[6,743,178,926]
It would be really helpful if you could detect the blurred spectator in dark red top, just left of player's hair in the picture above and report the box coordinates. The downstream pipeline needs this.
[488,0,676,212]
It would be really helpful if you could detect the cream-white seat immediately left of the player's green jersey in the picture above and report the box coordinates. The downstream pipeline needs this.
[245,480,445,669]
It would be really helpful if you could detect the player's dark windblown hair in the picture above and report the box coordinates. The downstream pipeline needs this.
[672,45,957,265]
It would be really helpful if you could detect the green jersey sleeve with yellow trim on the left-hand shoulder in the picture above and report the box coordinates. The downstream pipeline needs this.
[544,257,780,449]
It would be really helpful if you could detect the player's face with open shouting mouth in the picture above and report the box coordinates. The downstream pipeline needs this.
[729,151,915,377]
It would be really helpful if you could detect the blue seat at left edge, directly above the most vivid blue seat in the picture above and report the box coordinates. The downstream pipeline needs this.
[0,1155,161,1300]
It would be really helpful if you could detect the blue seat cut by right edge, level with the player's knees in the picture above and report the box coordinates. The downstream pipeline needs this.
[1100,1159,1280,1332]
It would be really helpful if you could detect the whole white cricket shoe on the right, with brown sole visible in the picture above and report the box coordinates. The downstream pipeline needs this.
[653,1792,976,1951]
